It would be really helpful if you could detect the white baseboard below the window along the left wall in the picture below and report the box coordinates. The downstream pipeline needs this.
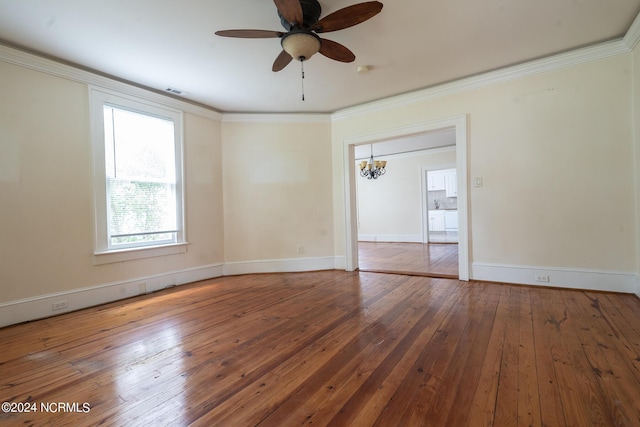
[0,264,223,327]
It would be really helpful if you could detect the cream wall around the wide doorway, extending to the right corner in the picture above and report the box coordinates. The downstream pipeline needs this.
[333,49,637,291]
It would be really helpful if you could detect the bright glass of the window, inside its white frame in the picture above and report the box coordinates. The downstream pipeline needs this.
[104,106,178,247]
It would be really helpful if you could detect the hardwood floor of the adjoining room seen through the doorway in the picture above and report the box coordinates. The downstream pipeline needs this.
[358,242,458,279]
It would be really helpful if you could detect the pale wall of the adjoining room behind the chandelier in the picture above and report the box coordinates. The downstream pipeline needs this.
[355,147,456,242]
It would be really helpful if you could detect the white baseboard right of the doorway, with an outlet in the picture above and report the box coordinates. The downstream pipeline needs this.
[471,262,640,296]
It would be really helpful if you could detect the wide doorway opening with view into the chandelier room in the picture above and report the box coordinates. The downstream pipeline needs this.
[355,143,458,278]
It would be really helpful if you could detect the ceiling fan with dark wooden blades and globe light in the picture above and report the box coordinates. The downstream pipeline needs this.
[216,0,382,71]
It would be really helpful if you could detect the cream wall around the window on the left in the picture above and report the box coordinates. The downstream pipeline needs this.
[0,54,224,326]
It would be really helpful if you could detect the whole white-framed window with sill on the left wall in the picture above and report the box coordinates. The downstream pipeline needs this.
[90,88,185,263]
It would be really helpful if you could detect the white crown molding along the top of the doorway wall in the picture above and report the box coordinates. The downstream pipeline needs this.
[331,38,640,121]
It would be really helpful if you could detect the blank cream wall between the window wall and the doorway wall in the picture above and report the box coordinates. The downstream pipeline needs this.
[222,115,334,274]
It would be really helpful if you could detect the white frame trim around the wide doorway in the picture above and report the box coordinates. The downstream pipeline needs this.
[343,115,469,280]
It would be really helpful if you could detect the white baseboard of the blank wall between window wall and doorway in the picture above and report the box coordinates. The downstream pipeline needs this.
[223,257,344,276]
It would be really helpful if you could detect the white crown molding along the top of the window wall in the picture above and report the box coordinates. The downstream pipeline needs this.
[0,44,222,120]
